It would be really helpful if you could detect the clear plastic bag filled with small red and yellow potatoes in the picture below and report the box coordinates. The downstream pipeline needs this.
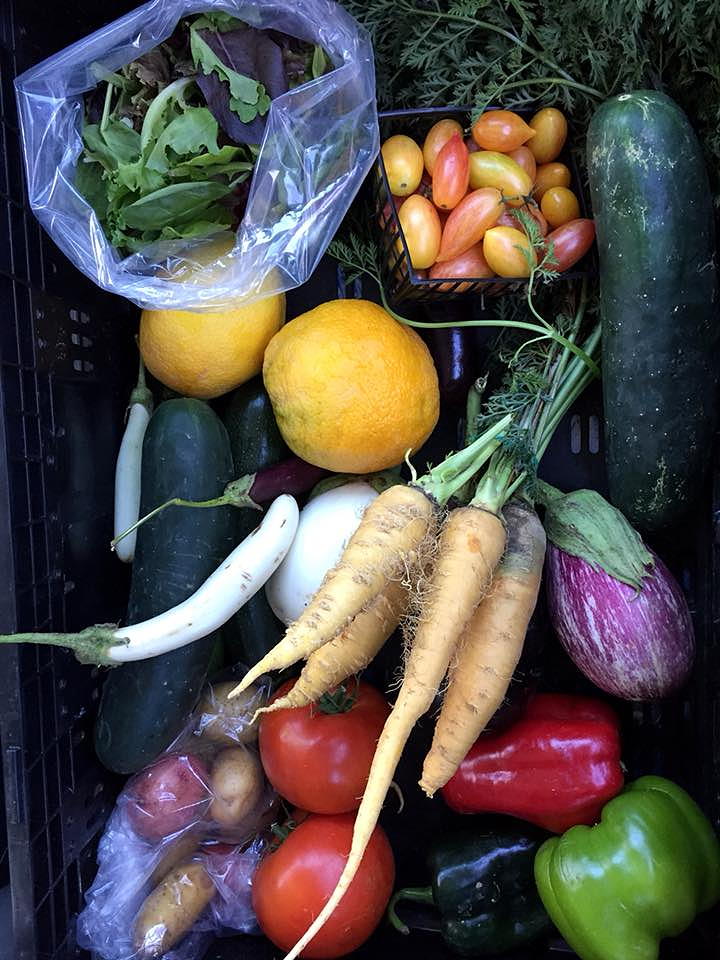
[77,681,278,960]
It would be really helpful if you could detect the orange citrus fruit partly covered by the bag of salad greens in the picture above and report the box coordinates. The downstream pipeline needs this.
[140,293,285,400]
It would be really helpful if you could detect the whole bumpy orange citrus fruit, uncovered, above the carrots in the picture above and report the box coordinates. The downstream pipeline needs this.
[263,300,440,473]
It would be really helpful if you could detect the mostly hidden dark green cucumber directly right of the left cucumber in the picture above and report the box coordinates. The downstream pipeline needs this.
[222,377,291,666]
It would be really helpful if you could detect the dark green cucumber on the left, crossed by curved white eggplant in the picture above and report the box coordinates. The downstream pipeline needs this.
[95,399,236,773]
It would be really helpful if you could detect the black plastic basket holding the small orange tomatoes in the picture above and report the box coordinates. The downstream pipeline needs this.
[370,106,594,304]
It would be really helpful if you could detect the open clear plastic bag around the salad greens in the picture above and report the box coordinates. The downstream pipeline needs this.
[15,0,379,310]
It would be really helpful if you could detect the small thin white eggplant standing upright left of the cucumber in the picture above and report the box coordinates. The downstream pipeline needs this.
[113,358,153,563]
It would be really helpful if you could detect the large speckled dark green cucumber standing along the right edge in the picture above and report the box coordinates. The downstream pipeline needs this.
[587,90,720,532]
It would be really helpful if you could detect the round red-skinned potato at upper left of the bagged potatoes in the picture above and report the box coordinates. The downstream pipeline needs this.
[125,753,212,843]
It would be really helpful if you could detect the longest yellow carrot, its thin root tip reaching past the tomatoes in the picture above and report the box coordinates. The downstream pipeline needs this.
[278,507,505,960]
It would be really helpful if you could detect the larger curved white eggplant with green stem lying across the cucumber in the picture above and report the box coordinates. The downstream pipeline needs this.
[0,494,299,666]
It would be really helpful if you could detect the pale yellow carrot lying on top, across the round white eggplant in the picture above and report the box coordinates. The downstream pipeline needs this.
[230,484,436,697]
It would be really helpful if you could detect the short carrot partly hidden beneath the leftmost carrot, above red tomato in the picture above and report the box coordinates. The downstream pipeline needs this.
[258,580,409,714]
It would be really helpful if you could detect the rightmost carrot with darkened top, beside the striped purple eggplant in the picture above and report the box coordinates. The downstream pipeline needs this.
[420,502,545,797]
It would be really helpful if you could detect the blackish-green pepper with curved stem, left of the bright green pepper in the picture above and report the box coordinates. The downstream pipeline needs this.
[388,818,552,957]
